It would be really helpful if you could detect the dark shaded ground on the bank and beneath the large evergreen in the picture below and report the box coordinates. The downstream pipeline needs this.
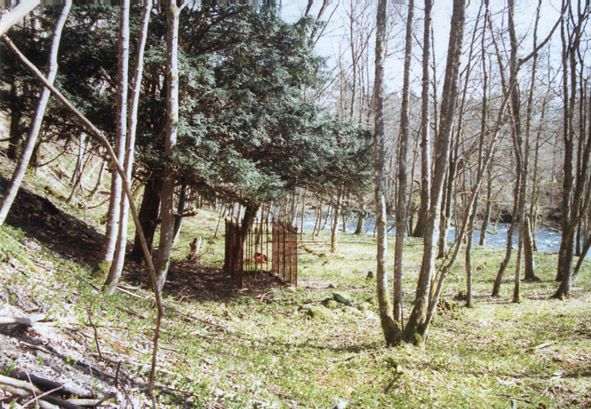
[0,176,283,302]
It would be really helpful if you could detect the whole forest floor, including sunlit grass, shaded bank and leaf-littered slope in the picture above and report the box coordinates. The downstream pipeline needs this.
[0,151,591,408]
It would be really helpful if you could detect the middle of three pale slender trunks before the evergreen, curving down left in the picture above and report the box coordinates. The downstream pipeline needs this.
[104,0,152,293]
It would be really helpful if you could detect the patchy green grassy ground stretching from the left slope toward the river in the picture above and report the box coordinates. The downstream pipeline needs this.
[0,151,591,408]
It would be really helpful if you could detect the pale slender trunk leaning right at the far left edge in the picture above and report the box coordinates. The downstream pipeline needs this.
[0,0,72,226]
